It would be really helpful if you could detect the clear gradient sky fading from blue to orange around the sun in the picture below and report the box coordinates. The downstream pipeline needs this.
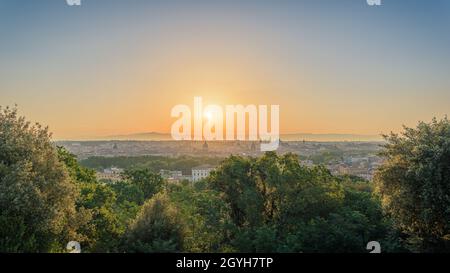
[0,0,450,139]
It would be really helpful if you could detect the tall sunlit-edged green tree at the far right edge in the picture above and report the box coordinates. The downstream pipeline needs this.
[375,118,450,252]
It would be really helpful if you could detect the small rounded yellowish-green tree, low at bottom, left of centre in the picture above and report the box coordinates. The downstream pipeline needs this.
[124,193,184,253]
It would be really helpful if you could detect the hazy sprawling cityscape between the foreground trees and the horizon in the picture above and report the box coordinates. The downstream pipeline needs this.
[56,141,383,181]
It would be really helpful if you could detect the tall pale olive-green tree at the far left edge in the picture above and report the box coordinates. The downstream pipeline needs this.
[0,105,86,252]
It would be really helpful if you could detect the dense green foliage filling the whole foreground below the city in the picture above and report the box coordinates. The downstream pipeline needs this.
[0,105,450,252]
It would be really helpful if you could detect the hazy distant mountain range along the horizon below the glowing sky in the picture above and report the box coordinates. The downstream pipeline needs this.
[83,132,382,142]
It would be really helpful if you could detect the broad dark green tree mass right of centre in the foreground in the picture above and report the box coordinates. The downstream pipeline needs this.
[207,153,393,252]
